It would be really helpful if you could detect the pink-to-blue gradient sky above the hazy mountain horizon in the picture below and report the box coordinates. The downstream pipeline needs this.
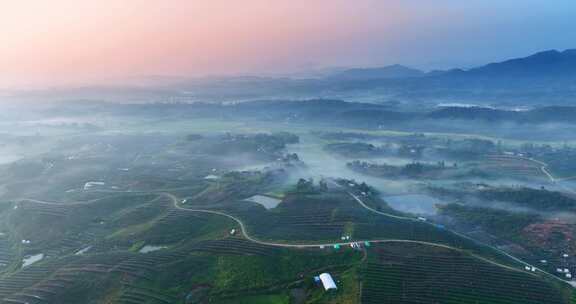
[0,0,576,88]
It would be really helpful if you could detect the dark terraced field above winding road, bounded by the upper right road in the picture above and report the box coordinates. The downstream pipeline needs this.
[216,190,536,267]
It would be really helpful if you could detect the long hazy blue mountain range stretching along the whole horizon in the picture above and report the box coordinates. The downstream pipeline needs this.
[12,49,576,106]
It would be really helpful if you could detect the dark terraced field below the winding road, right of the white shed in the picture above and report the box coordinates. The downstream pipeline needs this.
[362,243,569,304]
